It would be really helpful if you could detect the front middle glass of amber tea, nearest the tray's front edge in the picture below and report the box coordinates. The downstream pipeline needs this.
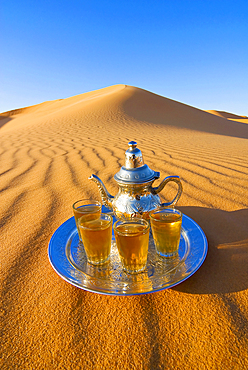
[113,218,150,274]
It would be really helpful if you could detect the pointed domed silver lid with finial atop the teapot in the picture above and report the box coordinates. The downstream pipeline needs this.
[114,141,160,184]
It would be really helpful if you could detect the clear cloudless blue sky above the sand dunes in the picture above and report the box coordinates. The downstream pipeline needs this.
[0,0,248,116]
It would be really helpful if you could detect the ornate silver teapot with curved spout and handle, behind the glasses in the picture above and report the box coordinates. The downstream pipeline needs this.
[89,141,182,219]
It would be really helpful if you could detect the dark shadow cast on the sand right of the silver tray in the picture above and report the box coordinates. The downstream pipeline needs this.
[173,207,248,294]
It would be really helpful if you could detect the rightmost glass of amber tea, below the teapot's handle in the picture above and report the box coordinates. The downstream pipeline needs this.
[149,207,182,257]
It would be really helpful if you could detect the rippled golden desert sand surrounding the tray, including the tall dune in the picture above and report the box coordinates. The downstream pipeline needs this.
[0,85,248,370]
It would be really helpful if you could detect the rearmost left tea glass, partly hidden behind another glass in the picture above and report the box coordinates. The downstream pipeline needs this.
[72,199,102,241]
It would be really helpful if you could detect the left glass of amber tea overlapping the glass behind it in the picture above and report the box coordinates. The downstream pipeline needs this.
[78,214,113,265]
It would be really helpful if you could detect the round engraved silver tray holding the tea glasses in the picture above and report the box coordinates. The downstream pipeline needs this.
[48,210,208,296]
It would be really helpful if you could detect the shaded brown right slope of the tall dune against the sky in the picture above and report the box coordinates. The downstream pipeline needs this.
[123,88,248,139]
